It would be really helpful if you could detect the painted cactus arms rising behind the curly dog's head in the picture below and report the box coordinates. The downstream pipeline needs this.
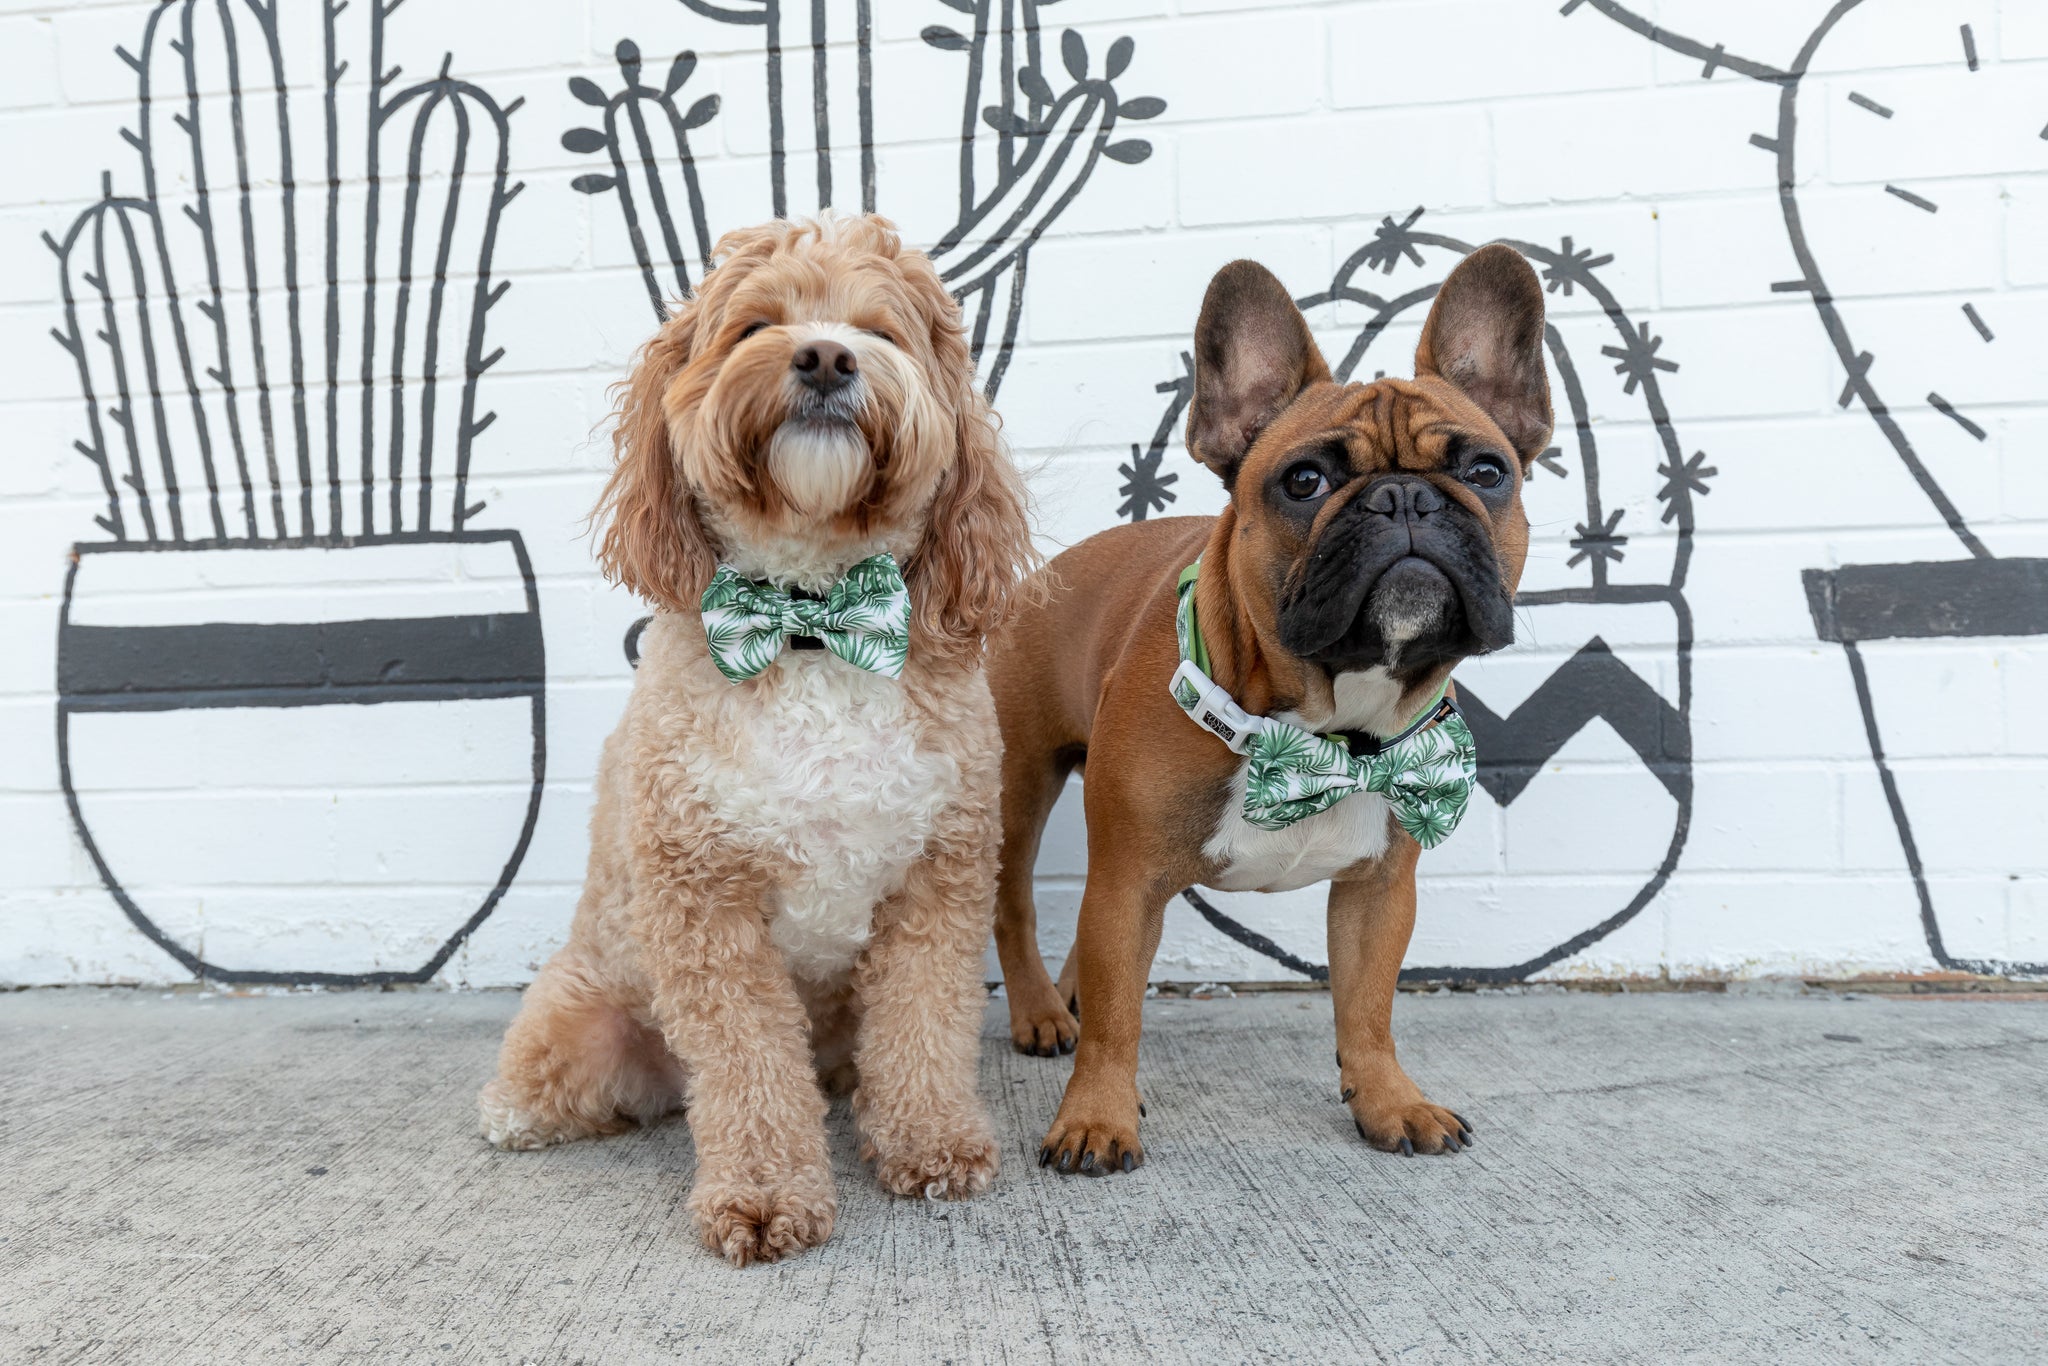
[561,0,1165,397]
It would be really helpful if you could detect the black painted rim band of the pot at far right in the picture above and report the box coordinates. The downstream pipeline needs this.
[1804,559,2048,643]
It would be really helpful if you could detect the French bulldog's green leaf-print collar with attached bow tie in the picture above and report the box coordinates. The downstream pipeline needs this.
[1174,561,1479,850]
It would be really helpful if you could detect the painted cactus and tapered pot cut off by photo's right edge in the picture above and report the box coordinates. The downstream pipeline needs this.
[1567,0,2048,977]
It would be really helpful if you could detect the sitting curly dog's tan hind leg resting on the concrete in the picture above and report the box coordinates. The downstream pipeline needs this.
[477,948,684,1149]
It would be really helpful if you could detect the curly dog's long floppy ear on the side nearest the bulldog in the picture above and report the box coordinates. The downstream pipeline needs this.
[903,264,1038,655]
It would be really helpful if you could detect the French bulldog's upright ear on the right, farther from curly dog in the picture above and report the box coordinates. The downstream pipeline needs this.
[1415,244,1550,469]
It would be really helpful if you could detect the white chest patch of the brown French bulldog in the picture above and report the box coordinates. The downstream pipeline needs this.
[1202,668,1401,891]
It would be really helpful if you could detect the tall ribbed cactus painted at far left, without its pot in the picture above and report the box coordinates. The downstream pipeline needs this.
[45,0,522,543]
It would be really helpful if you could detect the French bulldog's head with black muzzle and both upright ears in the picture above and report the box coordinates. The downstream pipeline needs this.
[1188,246,1550,682]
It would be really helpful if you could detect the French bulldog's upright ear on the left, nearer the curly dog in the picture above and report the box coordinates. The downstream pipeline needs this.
[1188,260,1329,487]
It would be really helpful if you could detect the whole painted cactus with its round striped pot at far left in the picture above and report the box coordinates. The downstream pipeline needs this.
[47,0,545,983]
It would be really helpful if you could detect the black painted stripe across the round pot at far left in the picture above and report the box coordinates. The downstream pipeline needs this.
[57,612,547,711]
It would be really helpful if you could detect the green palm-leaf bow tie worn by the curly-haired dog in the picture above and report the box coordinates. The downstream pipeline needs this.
[698,551,909,682]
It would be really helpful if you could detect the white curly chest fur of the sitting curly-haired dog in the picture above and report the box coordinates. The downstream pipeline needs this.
[694,651,961,979]
